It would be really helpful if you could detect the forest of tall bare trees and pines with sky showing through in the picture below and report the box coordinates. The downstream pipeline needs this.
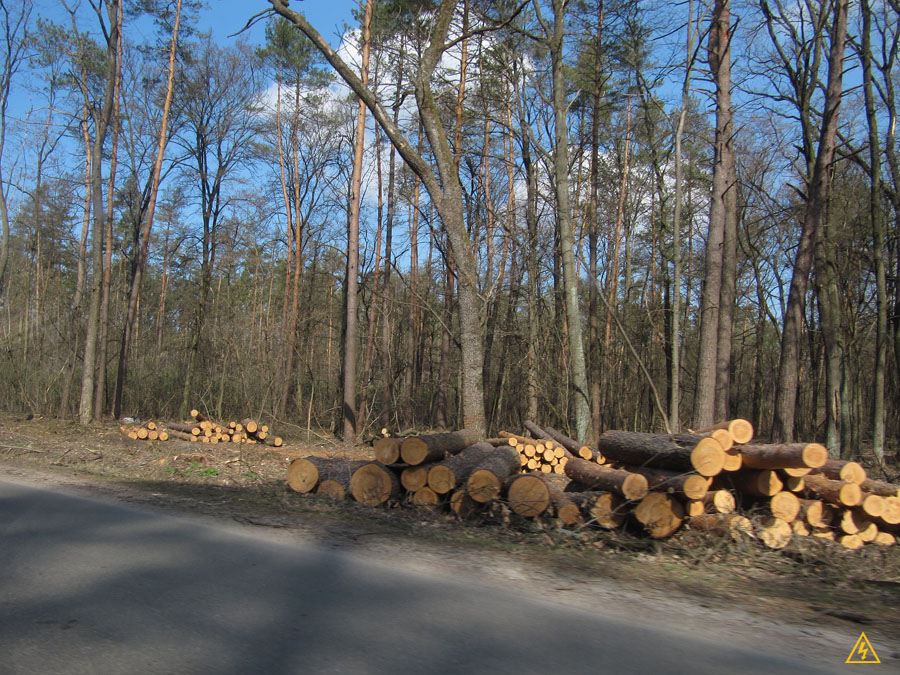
[0,0,900,462]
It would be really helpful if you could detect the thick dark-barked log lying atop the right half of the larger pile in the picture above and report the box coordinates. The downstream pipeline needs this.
[597,431,725,476]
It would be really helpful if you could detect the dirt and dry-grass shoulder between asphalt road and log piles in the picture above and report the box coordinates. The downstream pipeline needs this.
[0,416,900,663]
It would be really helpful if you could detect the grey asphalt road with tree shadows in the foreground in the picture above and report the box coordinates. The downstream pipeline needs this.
[0,481,848,675]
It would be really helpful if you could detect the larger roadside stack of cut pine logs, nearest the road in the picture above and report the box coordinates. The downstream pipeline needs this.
[288,420,900,549]
